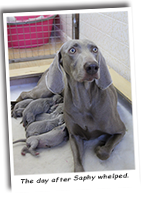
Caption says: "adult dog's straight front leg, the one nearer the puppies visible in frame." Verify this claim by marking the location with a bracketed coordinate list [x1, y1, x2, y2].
[70, 134, 84, 172]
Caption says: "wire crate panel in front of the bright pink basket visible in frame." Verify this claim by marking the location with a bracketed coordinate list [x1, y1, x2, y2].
[7, 14, 75, 63]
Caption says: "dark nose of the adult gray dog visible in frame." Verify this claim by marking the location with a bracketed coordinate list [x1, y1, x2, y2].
[84, 62, 99, 75]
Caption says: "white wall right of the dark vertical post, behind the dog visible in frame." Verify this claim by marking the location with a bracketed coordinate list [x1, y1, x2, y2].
[80, 12, 130, 81]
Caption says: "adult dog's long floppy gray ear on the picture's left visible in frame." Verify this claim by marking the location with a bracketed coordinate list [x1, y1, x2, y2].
[45, 47, 64, 94]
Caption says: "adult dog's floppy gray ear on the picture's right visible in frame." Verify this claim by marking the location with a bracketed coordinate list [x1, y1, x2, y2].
[96, 51, 112, 90]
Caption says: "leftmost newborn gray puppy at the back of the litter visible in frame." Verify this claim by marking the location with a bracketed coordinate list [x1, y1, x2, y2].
[11, 99, 33, 119]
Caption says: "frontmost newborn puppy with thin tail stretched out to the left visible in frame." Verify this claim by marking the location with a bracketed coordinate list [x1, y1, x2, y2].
[13, 123, 68, 156]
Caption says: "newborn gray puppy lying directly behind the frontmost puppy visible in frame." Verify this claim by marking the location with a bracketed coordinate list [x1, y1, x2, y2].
[26, 114, 64, 138]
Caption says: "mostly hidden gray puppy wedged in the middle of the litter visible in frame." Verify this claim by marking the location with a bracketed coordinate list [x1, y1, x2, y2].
[35, 103, 63, 121]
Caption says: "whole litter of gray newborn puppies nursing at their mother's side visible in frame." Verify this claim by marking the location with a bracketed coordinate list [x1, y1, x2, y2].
[11, 95, 68, 156]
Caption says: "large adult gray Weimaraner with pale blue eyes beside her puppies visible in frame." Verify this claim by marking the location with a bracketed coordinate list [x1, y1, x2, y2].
[15, 40, 126, 172]
